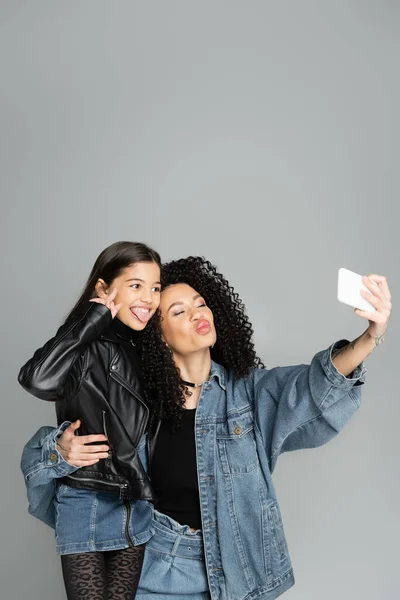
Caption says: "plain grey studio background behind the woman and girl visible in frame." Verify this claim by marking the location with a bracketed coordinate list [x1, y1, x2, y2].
[0, 0, 400, 600]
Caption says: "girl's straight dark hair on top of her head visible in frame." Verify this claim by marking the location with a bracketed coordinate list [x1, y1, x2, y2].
[65, 242, 161, 321]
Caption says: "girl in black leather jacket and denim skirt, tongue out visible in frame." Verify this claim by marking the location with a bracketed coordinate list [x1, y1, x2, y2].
[19, 242, 161, 600]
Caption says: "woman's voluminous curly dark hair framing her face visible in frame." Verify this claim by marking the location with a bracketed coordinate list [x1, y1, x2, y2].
[141, 256, 264, 426]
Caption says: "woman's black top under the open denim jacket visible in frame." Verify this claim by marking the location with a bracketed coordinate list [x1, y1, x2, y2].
[151, 408, 201, 529]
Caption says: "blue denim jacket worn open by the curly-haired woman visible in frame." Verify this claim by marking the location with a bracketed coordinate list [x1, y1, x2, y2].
[22, 340, 366, 600]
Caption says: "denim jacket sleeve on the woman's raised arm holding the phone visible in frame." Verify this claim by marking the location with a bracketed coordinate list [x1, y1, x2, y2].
[254, 340, 366, 471]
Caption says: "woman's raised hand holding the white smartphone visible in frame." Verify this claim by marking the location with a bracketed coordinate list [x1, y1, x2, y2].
[354, 275, 392, 346]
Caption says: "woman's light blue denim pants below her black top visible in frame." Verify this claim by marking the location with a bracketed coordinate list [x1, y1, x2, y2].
[136, 511, 210, 600]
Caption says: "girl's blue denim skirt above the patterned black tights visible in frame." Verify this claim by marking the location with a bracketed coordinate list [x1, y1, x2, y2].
[55, 483, 154, 554]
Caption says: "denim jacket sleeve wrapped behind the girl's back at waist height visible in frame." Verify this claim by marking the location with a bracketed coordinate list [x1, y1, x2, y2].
[21, 421, 79, 529]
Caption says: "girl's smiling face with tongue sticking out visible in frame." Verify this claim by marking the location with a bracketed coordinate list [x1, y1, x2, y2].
[96, 262, 161, 331]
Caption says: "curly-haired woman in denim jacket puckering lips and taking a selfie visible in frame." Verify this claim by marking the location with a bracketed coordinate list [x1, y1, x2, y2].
[21, 257, 391, 600]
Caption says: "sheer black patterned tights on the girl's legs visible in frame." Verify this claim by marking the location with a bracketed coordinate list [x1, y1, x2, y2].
[61, 545, 144, 600]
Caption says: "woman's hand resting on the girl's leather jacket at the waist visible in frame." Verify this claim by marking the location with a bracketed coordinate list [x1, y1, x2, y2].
[56, 419, 110, 467]
